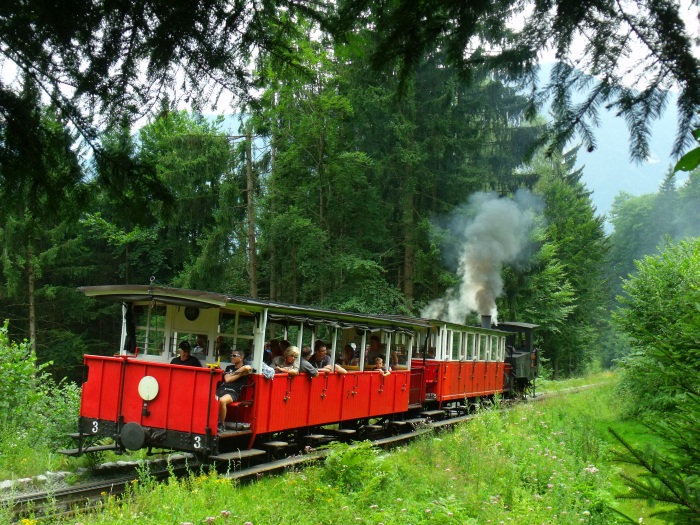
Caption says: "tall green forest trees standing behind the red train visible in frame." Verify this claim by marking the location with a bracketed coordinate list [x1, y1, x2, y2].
[0, 2, 700, 379]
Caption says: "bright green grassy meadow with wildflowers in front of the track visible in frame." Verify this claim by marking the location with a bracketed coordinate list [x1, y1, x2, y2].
[49, 374, 660, 525]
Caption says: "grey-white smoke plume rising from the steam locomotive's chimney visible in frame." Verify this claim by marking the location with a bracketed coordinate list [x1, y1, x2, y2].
[421, 190, 541, 323]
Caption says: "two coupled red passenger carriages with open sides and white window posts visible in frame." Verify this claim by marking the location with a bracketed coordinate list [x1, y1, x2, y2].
[66, 285, 536, 459]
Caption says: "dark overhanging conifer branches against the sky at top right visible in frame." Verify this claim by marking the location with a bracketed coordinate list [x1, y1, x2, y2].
[332, 0, 700, 160]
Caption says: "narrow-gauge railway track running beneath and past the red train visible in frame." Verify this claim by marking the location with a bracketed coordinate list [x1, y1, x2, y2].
[8, 384, 599, 522]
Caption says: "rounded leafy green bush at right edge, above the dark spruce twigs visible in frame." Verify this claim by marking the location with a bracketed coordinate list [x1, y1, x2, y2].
[615, 238, 700, 413]
